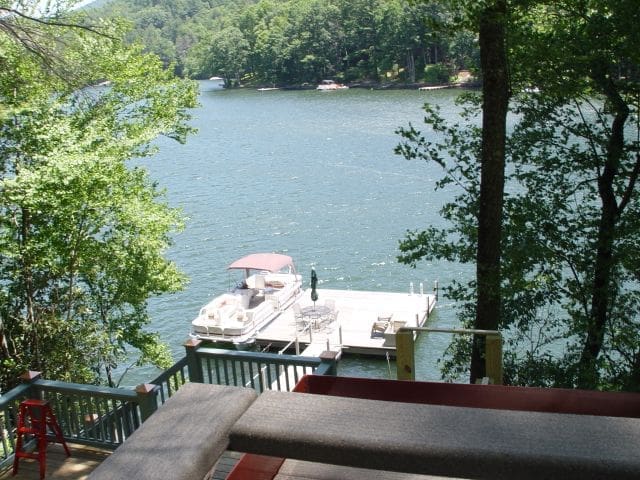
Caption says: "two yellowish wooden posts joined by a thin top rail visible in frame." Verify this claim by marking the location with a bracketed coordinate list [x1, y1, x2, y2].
[396, 326, 503, 385]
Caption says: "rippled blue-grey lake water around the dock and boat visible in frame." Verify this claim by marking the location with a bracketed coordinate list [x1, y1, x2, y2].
[123, 82, 473, 385]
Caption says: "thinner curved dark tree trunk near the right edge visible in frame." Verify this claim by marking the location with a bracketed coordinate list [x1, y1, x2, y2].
[578, 65, 629, 389]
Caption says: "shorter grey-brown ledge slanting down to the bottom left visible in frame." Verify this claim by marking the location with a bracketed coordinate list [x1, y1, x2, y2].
[88, 383, 257, 480]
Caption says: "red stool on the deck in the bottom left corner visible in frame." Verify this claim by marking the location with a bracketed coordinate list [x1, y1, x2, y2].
[13, 399, 71, 480]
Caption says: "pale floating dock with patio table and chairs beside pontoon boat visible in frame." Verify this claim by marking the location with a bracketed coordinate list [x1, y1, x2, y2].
[256, 289, 436, 356]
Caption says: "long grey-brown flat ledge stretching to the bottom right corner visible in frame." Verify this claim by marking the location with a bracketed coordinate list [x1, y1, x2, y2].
[229, 391, 640, 480]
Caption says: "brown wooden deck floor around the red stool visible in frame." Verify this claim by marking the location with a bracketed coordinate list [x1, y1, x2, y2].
[0, 444, 241, 480]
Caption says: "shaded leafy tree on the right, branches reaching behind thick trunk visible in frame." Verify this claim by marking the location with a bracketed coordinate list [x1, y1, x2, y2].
[399, 1, 640, 390]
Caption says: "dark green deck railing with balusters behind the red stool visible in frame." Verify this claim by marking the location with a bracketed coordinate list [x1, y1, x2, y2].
[0, 341, 336, 466]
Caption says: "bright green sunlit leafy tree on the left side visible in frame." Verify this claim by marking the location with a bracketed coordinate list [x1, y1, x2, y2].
[0, 2, 197, 389]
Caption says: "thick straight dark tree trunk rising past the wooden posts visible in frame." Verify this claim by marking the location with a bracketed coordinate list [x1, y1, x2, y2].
[470, 0, 509, 383]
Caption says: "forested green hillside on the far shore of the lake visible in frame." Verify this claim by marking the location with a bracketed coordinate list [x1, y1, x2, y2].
[94, 0, 478, 86]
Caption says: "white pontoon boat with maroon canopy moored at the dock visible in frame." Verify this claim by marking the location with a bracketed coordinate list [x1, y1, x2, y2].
[190, 253, 302, 348]
